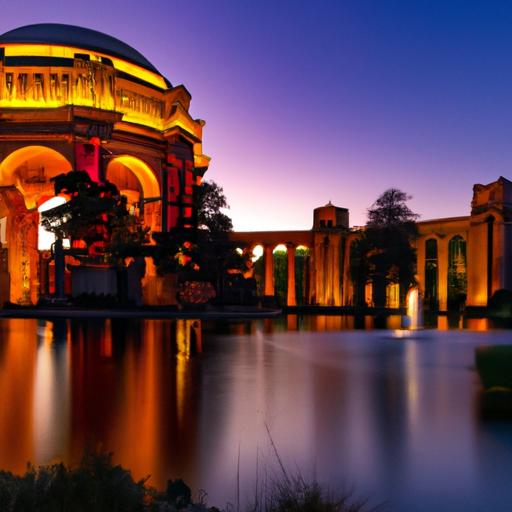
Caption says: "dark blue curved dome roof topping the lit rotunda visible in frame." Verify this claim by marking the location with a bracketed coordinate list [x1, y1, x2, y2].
[0, 23, 160, 75]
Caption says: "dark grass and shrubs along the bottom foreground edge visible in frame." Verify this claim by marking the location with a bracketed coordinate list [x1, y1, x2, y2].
[0, 454, 382, 512]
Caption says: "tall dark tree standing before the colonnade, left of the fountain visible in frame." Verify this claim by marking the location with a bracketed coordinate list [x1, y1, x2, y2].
[351, 188, 418, 307]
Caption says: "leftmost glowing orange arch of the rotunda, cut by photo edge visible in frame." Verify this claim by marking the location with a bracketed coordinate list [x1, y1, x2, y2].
[0, 146, 72, 209]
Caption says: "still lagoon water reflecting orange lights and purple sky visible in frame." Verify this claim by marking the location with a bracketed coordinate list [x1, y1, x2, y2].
[0, 316, 512, 512]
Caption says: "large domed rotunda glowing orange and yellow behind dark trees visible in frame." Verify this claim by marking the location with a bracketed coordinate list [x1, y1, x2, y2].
[0, 24, 209, 304]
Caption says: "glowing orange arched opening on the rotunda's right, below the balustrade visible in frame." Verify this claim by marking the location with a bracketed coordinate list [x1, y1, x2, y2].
[105, 155, 161, 231]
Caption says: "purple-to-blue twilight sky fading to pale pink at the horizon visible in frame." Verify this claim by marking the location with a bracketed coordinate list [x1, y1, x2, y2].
[0, 0, 512, 230]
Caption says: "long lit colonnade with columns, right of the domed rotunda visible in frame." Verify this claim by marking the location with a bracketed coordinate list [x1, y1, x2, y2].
[232, 177, 512, 311]
